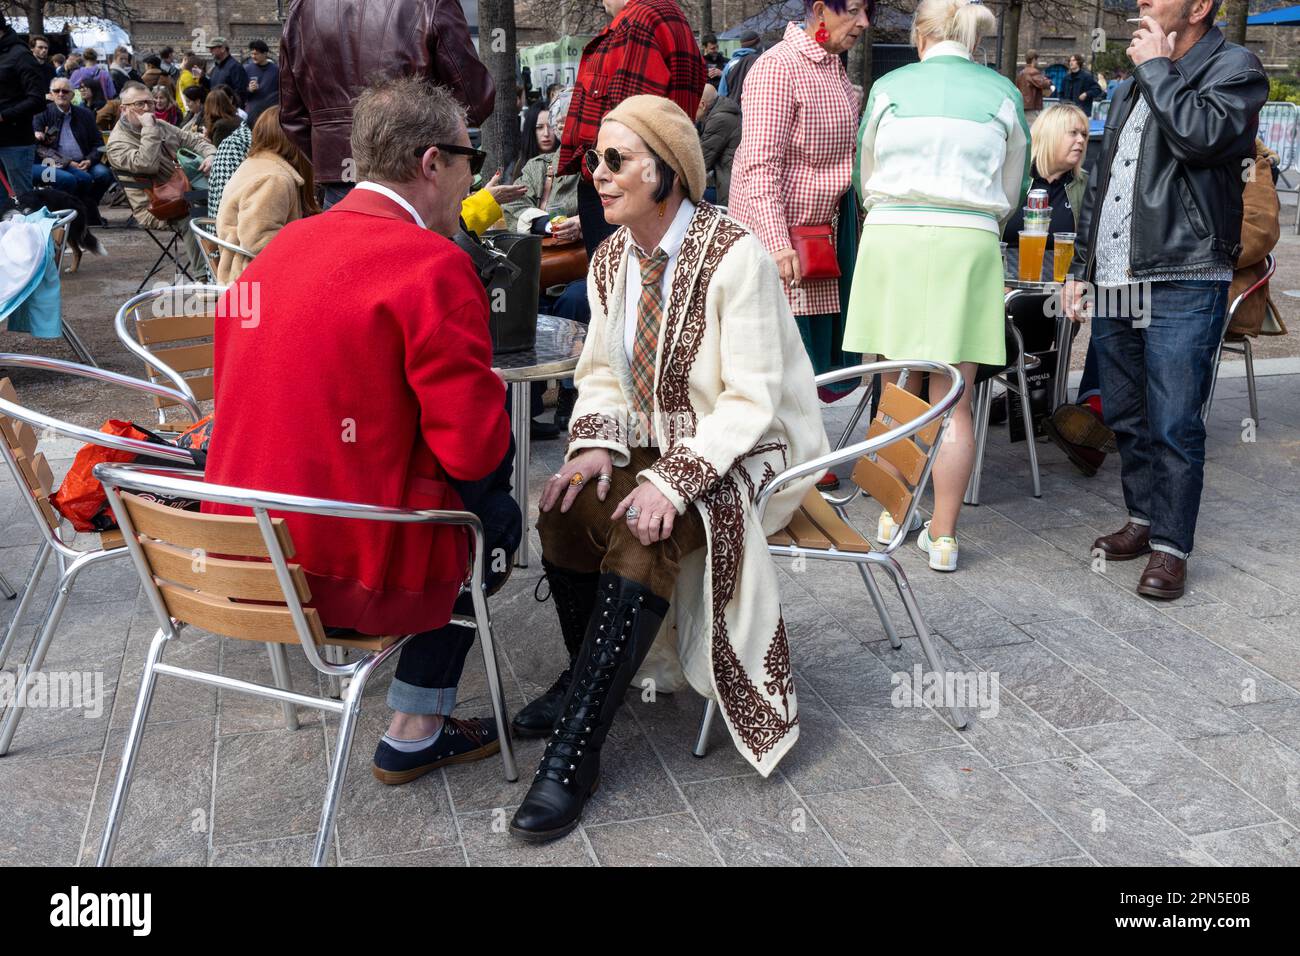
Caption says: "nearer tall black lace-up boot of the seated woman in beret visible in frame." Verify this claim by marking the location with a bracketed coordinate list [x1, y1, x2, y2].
[510, 574, 668, 843]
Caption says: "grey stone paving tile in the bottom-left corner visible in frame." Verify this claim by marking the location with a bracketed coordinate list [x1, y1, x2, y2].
[0, 753, 99, 866]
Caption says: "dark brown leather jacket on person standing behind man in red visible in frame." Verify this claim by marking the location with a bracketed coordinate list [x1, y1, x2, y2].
[280, 0, 497, 182]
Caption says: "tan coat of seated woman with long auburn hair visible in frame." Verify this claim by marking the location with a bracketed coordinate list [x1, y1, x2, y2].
[217, 152, 303, 285]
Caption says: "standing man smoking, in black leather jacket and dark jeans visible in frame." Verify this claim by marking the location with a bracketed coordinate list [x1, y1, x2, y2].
[1063, 0, 1269, 600]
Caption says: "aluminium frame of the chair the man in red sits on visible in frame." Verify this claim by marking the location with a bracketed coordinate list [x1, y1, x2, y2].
[95, 463, 519, 866]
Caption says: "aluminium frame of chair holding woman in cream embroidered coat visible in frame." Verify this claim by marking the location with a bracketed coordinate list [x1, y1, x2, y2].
[693, 359, 970, 757]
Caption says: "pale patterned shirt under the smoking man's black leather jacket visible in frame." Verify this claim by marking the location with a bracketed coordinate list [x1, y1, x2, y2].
[1093, 90, 1232, 286]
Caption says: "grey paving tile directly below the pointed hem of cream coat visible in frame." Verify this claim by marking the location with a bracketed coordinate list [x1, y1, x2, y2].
[683, 777, 844, 866]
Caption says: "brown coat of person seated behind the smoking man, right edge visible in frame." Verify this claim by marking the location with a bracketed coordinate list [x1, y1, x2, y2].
[1227, 139, 1287, 336]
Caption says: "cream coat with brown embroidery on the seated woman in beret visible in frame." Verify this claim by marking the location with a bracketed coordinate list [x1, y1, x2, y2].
[568, 203, 829, 777]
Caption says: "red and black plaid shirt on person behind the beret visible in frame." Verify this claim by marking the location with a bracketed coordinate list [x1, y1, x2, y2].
[559, 0, 707, 179]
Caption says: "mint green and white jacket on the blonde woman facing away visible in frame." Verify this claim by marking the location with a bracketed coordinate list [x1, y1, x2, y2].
[853, 42, 1030, 235]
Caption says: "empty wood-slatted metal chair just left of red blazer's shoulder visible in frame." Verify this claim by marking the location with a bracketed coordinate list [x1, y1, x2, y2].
[113, 285, 225, 432]
